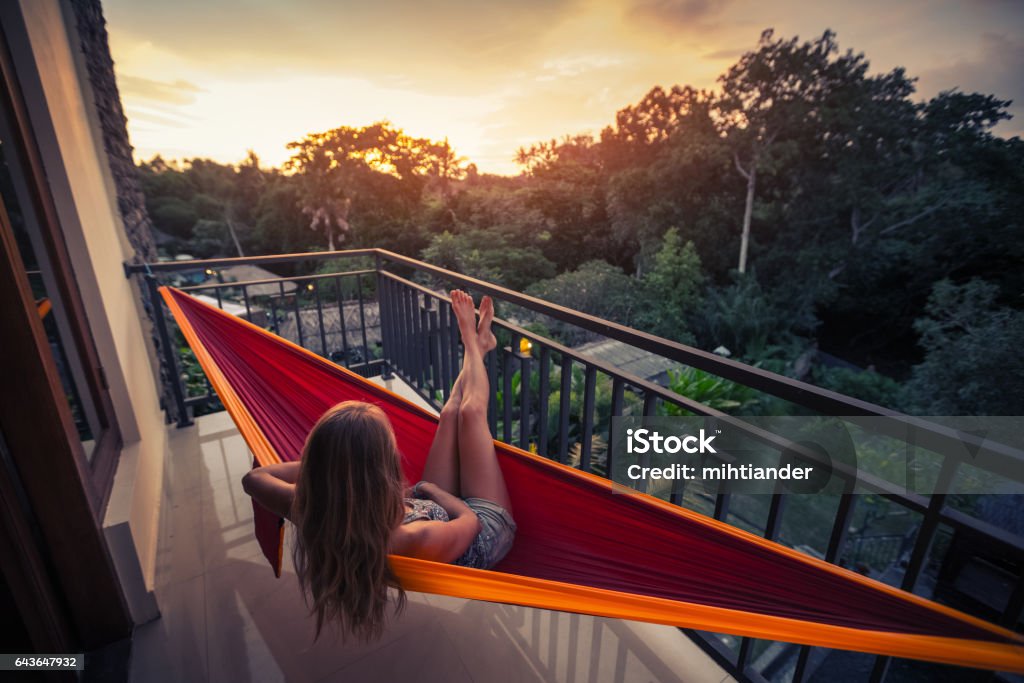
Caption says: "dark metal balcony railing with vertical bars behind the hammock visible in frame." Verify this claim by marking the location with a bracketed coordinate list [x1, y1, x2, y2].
[125, 249, 1024, 683]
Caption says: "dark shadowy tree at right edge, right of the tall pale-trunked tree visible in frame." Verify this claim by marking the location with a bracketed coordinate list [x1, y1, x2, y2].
[802, 90, 1024, 376]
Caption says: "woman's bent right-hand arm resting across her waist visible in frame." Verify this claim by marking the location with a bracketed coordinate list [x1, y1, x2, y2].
[391, 481, 480, 562]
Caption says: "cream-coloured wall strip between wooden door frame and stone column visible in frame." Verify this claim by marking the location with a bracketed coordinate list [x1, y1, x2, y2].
[11, 0, 168, 623]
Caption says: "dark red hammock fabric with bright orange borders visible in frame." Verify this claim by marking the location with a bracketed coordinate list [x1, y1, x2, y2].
[161, 288, 1024, 673]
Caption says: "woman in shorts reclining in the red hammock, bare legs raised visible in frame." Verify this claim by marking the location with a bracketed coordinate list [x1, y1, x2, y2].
[242, 291, 516, 638]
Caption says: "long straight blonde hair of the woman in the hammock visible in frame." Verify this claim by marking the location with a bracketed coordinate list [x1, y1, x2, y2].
[292, 400, 406, 640]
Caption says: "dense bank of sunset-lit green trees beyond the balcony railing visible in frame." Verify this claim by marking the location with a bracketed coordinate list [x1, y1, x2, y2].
[141, 32, 1024, 414]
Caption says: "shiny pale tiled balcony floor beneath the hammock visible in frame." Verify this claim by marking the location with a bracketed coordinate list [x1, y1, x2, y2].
[131, 413, 731, 683]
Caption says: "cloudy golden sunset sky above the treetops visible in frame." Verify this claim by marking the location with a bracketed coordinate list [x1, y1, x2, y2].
[103, 0, 1024, 173]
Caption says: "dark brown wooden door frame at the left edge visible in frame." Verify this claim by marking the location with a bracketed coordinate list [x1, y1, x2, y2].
[0, 13, 132, 651]
